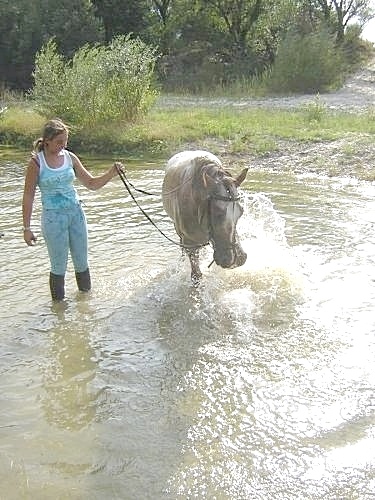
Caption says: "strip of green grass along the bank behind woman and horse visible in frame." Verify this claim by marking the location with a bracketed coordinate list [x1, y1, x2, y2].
[0, 99, 375, 155]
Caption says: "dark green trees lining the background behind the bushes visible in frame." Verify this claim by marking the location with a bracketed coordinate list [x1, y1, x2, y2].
[0, 0, 374, 92]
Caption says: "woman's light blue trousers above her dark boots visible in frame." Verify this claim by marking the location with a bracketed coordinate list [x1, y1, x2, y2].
[41, 204, 88, 275]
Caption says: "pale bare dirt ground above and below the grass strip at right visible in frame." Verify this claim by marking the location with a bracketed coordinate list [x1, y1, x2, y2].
[167, 59, 375, 181]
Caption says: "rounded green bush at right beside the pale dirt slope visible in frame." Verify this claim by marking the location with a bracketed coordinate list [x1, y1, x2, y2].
[270, 30, 343, 93]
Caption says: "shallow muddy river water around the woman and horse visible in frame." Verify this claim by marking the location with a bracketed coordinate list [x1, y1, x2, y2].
[0, 152, 375, 500]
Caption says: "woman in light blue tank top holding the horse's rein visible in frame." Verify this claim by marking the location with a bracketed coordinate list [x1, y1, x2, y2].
[22, 119, 123, 301]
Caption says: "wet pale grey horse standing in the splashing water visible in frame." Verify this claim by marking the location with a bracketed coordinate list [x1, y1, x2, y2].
[162, 151, 247, 281]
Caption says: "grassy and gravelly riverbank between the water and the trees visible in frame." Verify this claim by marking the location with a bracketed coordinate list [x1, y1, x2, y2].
[0, 61, 375, 181]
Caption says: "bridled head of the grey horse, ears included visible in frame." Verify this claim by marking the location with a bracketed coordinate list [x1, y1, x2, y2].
[202, 165, 248, 268]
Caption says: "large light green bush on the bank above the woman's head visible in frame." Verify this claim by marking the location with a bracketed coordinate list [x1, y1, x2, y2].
[31, 37, 156, 128]
